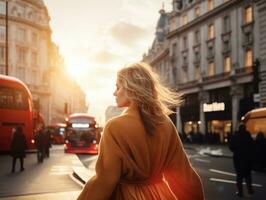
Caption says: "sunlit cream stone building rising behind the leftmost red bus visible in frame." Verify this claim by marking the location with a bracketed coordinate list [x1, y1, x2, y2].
[0, 0, 86, 124]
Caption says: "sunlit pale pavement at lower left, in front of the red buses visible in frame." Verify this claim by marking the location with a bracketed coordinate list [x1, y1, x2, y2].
[0, 145, 82, 200]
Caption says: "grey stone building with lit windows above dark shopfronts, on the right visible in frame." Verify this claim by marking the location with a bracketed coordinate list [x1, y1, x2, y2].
[144, 0, 260, 142]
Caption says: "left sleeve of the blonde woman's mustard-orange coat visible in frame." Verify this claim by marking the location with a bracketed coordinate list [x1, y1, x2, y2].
[78, 121, 121, 200]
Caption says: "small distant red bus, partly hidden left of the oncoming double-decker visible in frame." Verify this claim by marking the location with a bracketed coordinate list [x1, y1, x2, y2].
[45, 123, 66, 144]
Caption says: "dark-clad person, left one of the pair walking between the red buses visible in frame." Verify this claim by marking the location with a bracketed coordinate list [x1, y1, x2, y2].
[34, 126, 45, 163]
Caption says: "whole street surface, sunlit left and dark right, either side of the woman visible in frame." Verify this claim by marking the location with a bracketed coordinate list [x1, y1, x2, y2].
[0, 144, 266, 200]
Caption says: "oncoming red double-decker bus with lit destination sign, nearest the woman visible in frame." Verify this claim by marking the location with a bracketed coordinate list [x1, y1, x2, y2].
[65, 113, 101, 154]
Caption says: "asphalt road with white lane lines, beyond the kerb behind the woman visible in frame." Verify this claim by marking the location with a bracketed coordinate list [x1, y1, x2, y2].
[78, 146, 266, 200]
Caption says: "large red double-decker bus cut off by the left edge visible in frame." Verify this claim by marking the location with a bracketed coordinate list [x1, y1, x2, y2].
[0, 75, 34, 151]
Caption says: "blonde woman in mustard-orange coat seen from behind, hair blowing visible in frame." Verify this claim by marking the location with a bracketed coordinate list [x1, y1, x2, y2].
[78, 62, 204, 200]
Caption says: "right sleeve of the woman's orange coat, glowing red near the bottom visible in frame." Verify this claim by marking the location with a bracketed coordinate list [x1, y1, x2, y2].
[164, 126, 204, 200]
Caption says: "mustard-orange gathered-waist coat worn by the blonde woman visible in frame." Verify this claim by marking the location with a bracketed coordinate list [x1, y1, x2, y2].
[78, 107, 204, 200]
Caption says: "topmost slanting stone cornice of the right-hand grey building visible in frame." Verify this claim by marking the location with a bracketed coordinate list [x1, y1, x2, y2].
[166, 0, 244, 39]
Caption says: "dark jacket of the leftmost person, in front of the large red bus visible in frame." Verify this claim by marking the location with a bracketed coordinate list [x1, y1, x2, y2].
[10, 131, 27, 158]
